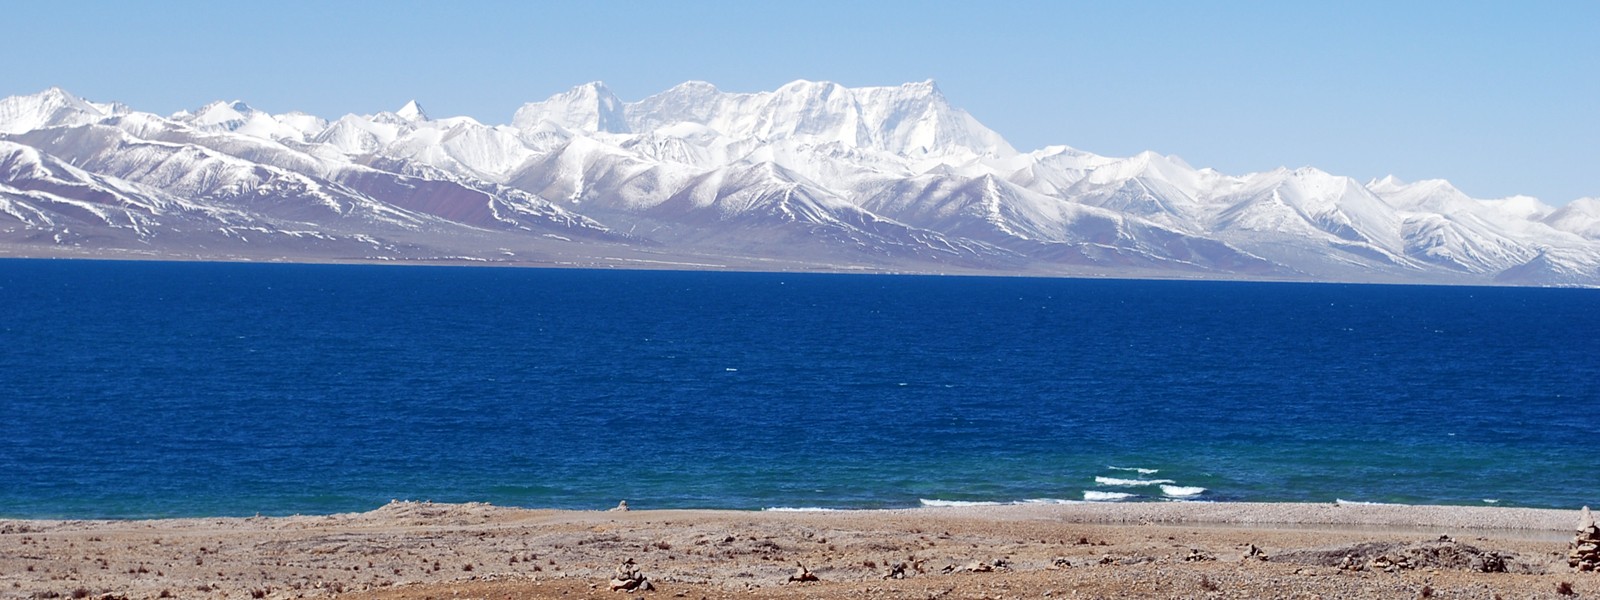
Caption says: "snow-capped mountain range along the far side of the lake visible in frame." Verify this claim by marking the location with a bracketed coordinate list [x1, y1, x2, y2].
[0, 82, 1600, 286]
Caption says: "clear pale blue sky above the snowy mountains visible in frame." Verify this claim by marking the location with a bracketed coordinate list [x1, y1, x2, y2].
[0, 0, 1600, 205]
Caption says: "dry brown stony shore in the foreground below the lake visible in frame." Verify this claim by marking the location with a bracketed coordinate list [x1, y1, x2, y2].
[0, 502, 1600, 600]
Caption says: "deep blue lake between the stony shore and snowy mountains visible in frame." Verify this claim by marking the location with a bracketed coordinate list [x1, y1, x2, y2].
[0, 261, 1600, 517]
